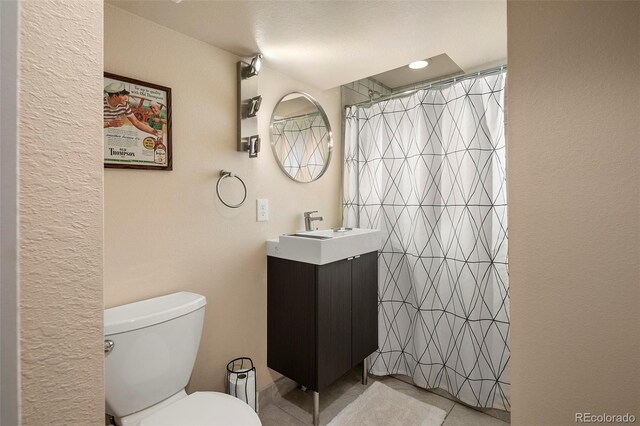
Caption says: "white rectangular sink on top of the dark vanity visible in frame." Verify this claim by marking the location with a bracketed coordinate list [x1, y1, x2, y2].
[267, 228, 382, 265]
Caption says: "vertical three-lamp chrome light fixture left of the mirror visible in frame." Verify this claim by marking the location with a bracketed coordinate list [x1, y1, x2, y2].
[237, 53, 262, 158]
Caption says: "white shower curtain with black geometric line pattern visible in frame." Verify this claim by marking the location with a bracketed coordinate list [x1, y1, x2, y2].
[343, 71, 510, 411]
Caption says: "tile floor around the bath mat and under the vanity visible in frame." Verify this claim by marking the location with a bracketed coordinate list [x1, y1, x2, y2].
[260, 369, 509, 426]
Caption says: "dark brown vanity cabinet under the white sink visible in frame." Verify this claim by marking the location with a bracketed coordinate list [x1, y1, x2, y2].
[267, 252, 378, 392]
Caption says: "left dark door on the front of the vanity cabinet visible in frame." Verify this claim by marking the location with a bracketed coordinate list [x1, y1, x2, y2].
[317, 260, 352, 390]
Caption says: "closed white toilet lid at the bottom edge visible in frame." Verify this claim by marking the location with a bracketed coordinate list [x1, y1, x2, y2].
[140, 392, 262, 426]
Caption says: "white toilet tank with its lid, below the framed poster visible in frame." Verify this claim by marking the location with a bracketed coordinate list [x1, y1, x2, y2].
[104, 292, 207, 417]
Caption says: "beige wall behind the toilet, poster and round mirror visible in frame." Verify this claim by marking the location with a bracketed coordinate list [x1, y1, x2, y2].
[104, 6, 341, 391]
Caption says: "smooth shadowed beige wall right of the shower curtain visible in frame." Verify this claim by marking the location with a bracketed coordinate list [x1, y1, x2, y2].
[507, 1, 640, 425]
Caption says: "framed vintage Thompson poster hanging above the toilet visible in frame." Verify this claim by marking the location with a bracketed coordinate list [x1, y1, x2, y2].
[103, 72, 172, 170]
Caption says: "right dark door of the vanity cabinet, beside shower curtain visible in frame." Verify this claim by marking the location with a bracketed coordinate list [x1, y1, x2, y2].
[350, 252, 378, 366]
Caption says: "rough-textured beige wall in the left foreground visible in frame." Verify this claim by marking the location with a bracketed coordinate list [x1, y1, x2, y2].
[19, 1, 104, 426]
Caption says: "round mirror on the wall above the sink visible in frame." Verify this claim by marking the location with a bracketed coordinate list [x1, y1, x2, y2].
[271, 92, 333, 182]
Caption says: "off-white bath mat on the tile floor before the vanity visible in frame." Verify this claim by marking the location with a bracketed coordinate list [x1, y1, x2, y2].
[327, 382, 447, 426]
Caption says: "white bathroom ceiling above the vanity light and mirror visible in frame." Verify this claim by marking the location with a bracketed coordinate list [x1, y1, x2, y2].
[107, 0, 507, 89]
